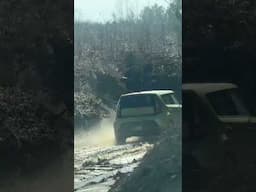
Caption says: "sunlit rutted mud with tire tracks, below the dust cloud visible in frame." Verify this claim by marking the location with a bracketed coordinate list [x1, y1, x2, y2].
[74, 143, 153, 192]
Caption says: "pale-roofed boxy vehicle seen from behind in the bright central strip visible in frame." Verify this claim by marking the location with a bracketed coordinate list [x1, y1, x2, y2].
[114, 90, 181, 144]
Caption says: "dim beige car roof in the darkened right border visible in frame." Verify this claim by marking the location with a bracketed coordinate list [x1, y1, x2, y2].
[182, 83, 237, 94]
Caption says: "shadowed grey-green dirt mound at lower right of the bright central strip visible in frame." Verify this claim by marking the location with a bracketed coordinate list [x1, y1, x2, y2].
[111, 127, 181, 192]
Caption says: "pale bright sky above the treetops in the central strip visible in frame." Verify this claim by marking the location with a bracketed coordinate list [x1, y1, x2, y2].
[74, 0, 167, 22]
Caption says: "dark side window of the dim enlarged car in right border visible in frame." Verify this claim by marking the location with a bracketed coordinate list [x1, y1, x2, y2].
[207, 89, 249, 116]
